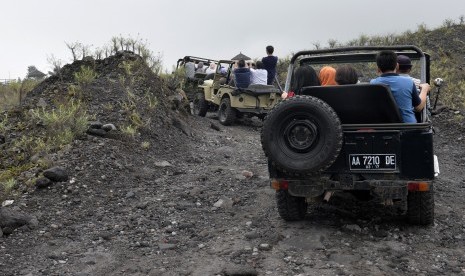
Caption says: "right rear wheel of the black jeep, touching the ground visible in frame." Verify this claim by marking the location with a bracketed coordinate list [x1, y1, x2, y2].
[407, 186, 434, 225]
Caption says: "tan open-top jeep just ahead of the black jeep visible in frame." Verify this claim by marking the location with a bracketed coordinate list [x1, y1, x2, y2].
[193, 60, 281, 125]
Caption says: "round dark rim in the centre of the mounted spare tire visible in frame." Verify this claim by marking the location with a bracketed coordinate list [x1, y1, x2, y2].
[284, 119, 319, 152]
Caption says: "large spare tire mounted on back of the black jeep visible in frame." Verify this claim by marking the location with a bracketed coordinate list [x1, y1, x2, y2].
[261, 96, 342, 175]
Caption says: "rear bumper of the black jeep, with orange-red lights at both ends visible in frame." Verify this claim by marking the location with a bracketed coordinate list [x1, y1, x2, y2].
[271, 179, 433, 199]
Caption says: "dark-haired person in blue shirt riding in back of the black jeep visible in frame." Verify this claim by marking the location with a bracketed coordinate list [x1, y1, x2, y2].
[370, 50, 431, 123]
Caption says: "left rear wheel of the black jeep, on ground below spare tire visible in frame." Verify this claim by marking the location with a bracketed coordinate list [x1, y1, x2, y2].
[276, 190, 307, 221]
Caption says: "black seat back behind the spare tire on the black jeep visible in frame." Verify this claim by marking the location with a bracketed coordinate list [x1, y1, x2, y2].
[299, 84, 402, 124]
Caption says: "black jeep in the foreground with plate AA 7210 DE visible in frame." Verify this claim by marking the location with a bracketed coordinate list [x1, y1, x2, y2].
[261, 46, 439, 225]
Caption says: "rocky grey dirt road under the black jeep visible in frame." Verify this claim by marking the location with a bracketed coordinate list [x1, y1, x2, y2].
[0, 109, 465, 275]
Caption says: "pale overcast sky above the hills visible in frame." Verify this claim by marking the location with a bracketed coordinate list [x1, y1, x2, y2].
[0, 0, 465, 79]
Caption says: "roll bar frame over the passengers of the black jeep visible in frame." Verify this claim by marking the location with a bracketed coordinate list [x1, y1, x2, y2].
[284, 45, 429, 91]
